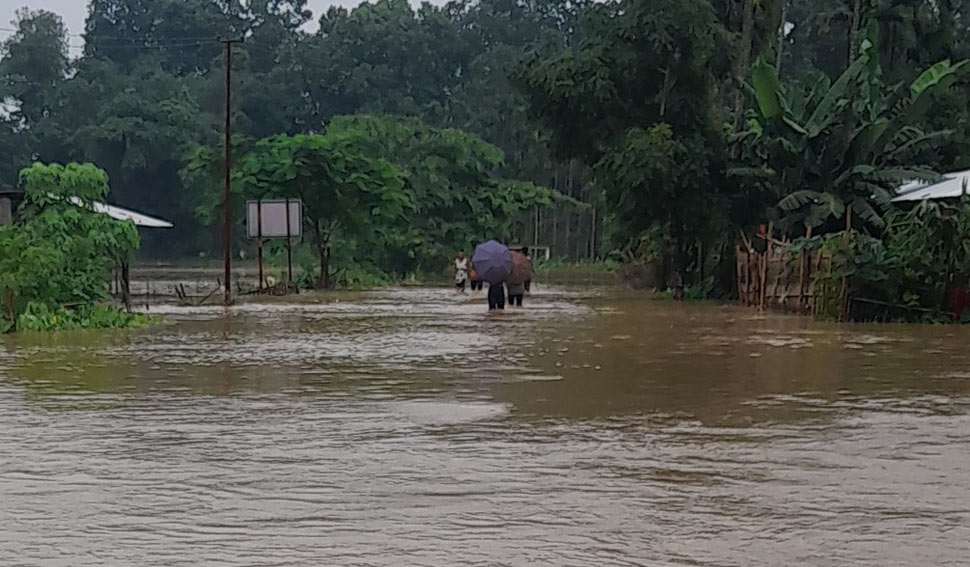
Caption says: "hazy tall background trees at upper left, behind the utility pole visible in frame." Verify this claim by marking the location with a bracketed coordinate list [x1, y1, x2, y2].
[0, 0, 587, 262]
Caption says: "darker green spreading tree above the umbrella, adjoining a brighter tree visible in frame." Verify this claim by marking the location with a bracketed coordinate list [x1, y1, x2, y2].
[327, 115, 579, 275]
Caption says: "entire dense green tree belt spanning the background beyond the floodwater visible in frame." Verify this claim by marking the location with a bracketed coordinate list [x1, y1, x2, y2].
[0, 0, 970, 316]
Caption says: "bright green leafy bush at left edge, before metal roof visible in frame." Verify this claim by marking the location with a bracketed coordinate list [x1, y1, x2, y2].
[0, 163, 138, 327]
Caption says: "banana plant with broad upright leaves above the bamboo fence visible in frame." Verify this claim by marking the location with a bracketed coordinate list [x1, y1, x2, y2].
[733, 39, 966, 237]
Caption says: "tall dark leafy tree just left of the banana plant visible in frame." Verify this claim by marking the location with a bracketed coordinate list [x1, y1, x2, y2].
[518, 0, 727, 284]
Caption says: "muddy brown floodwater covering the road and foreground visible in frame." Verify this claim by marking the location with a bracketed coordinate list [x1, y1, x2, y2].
[0, 288, 970, 567]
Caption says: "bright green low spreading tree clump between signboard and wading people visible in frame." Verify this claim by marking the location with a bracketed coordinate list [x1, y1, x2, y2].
[184, 115, 564, 286]
